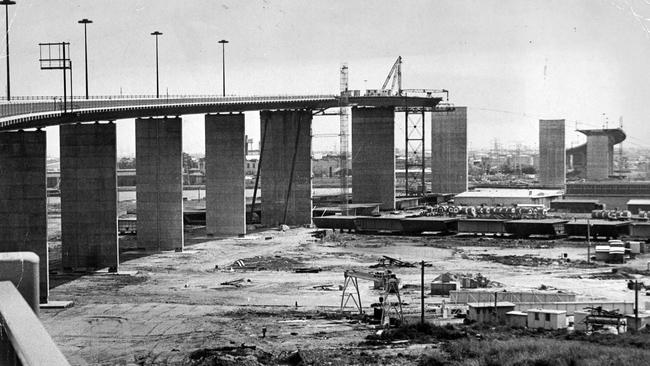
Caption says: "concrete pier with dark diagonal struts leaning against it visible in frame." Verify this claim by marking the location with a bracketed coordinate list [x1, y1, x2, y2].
[256, 110, 312, 226]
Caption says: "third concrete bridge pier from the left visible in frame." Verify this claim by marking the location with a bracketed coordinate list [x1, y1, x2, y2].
[135, 117, 184, 251]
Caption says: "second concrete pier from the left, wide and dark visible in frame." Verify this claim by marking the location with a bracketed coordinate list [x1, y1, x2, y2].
[59, 122, 119, 272]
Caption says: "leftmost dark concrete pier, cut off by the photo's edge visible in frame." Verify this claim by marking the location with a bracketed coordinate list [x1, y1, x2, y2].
[0, 130, 49, 303]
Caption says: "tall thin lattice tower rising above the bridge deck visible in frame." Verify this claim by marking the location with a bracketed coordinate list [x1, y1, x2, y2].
[339, 64, 349, 215]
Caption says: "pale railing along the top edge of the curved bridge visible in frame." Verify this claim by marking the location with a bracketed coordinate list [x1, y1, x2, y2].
[0, 94, 335, 117]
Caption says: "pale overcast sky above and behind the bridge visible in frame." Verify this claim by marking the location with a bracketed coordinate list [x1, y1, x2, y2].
[8, 0, 650, 153]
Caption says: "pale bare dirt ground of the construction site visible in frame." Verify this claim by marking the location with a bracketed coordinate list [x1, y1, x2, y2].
[41, 222, 650, 365]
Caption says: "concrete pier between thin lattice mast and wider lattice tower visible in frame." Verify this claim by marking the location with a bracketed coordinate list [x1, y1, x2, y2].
[352, 107, 395, 210]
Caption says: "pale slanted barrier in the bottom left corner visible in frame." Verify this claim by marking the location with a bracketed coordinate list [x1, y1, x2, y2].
[0, 281, 70, 366]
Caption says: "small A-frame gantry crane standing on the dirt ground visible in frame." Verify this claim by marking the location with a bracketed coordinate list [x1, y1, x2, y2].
[341, 270, 404, 325]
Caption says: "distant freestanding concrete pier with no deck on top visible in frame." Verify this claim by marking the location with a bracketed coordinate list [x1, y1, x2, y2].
[539, 119, 566, 188]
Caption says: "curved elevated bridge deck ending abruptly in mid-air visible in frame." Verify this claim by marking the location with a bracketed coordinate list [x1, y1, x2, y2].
[0, 95, 442, 131]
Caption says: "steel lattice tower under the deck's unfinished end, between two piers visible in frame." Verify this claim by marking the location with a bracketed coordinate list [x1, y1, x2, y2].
[404, 108, 427, 197]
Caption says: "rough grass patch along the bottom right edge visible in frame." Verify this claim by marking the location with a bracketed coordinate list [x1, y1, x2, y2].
[412, 324, 650, 366]
